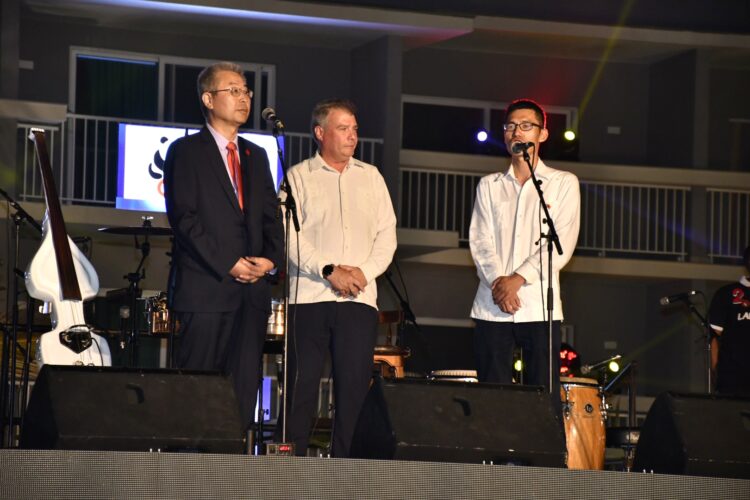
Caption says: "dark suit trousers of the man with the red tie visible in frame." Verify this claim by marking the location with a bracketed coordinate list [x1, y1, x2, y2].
[176, 303, 268, 428]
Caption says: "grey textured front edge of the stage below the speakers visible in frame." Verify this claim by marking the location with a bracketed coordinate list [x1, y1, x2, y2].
[0, 449, 750, 500]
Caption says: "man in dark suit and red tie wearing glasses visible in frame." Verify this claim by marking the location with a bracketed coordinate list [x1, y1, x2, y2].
[164, 63, 283, 426]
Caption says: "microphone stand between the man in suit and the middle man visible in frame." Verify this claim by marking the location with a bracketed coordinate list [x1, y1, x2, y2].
[270, 122, 300, 454]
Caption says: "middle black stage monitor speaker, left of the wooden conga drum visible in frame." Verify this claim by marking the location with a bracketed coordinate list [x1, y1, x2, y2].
[351, 377, 565, 467]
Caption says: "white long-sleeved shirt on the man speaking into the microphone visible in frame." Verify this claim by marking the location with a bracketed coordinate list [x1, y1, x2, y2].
[469, 159, 581, 323]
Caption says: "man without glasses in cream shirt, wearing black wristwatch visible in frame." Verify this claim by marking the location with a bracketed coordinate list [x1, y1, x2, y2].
[277, 100, 396, 457]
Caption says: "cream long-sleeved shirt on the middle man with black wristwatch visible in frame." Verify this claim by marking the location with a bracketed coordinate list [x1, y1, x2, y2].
[288, 153, 396, 308]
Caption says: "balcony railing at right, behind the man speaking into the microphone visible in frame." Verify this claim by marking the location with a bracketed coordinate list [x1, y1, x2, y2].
[399, 168, 732, 261]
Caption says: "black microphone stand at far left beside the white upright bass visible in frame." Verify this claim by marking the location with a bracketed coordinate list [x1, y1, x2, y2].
[0, 189, 42, 447]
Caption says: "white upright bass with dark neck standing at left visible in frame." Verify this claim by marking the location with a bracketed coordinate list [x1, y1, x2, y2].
[26, 129, 112, 366]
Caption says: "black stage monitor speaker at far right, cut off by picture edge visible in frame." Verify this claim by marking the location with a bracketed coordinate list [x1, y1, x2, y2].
[633, 392, 750, 478]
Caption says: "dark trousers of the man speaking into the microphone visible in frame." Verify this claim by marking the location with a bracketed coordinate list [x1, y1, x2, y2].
[474, 319, 562, 419]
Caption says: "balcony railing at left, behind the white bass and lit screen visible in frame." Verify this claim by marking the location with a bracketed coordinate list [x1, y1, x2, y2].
[16, 114, 383, 206]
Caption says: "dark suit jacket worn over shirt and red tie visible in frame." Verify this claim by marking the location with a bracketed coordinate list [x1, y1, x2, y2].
[164, 127, 284, 312]
